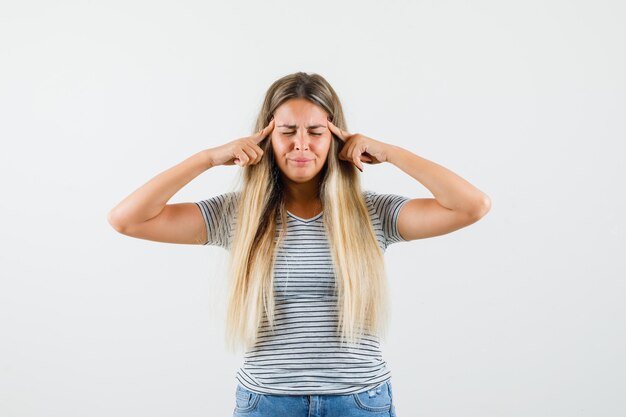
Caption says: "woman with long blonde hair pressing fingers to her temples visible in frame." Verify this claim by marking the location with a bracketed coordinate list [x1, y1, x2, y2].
[109, 72, 490, 416]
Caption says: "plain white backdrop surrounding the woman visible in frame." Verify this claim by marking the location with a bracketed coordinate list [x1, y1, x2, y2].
[0, 0, 626, 417]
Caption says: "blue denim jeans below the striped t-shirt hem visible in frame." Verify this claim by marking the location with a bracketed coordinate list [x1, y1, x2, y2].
[233, 381, 396, 417]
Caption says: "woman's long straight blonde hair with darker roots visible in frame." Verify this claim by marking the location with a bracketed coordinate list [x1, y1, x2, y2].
[225, 72, 389, 350]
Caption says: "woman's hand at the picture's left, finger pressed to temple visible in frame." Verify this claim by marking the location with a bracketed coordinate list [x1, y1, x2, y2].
[211, 117, 274, 167]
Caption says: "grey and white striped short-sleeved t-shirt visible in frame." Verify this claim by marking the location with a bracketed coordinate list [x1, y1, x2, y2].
[196, 191, 409, 395]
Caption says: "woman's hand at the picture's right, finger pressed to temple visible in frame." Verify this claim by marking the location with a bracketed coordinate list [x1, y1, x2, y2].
[327, 120, 389, 172]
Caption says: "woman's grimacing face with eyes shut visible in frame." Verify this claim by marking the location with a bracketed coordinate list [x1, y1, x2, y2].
[271, 98, 332, 183]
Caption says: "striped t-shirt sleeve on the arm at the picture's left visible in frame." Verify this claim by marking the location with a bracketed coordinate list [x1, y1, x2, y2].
[195, 192, 236, 249]
